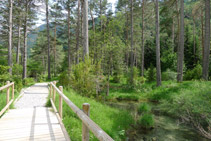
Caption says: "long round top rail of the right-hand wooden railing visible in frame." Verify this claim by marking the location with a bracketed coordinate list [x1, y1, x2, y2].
[51, 82, 113, 141]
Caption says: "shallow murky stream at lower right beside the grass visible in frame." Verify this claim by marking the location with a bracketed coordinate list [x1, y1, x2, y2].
[106, 102, 208, 141]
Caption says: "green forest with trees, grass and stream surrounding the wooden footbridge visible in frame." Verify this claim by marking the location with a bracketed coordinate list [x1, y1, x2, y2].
[0, 0, 211, 141]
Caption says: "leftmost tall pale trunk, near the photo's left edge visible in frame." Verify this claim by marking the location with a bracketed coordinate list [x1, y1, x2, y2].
[8, 0, 13, 75]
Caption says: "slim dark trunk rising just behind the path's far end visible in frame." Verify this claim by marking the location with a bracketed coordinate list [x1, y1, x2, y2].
[46, 0, 51, 79]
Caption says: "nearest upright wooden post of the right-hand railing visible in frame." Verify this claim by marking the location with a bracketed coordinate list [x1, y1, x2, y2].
[82, 103, 90, 141]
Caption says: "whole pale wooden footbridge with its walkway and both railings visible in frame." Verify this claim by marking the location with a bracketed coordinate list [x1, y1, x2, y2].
[0, 81, 113, 141]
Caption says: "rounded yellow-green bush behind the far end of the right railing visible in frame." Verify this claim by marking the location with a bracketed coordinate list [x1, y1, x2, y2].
[59, 59, 106, 97]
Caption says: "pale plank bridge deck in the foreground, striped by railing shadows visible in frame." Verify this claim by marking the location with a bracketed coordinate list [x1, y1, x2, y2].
[0, 83, 65, 141]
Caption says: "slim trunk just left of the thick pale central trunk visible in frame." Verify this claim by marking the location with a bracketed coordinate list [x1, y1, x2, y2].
[76, 0, 81, 64]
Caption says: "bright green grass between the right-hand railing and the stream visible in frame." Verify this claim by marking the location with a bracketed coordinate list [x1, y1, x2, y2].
[50, 90, 134, 141]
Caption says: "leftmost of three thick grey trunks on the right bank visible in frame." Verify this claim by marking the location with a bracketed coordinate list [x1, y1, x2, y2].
[155, 0, 161, 86]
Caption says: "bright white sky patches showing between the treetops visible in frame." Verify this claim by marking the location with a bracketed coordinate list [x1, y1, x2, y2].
[36, 0, 118, 26]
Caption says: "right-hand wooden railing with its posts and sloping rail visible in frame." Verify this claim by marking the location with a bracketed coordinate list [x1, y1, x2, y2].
[50, 81, 113, 141]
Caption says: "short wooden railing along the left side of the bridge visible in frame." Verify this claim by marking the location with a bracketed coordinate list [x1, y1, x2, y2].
[0, 81, 14, 116]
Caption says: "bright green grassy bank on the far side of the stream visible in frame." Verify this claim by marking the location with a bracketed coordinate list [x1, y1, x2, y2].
[108, 81, 211, 101]
